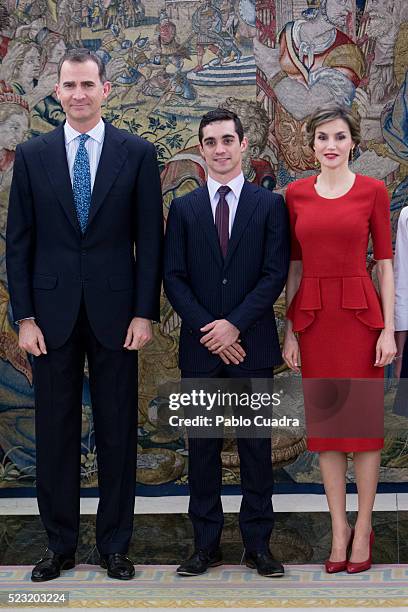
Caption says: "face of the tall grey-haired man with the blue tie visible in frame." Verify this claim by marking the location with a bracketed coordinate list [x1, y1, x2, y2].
[55, 60, 111, 127]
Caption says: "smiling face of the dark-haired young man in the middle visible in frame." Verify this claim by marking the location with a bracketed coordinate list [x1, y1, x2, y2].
[200, 119, 248, 182]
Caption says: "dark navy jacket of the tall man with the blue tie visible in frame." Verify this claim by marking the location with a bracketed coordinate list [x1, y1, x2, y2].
[7, 123, 163, 350]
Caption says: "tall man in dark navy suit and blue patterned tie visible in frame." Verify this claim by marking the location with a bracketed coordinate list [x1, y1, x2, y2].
[7, 49, 162, 582]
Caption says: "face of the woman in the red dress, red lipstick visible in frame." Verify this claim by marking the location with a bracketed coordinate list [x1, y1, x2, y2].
[314, 119, 354, 169]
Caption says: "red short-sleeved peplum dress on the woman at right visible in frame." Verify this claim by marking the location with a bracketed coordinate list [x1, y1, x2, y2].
[286, 174, 392, 452]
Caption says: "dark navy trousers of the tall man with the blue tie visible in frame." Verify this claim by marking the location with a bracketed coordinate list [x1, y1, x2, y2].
[34, 301, 137, 554]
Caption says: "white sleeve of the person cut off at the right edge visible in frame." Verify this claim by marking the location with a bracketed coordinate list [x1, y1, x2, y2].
[394, 206, 408, 331]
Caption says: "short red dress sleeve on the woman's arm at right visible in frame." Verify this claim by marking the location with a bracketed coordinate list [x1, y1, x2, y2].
[370, 182, 392, 260]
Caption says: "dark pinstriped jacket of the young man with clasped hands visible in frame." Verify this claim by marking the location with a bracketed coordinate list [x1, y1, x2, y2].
[164, 181, 289, 372]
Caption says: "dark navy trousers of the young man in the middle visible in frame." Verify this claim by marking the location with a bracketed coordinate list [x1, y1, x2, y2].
[181, 364, 274, 552]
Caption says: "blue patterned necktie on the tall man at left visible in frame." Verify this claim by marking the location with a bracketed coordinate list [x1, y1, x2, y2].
[72, 134, 91, 233]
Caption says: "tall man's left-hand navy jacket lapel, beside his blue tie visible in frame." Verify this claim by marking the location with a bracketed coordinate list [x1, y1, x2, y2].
[40, 125, 81, 232]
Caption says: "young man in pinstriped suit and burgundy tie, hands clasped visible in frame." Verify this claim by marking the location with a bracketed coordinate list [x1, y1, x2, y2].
[164, 109, 289, 576]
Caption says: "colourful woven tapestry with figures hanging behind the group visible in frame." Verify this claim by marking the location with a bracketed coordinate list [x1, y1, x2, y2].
[0, 0, 408, 492]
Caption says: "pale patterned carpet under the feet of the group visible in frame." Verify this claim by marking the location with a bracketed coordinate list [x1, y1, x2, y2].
[0, 565, 408, 609]
